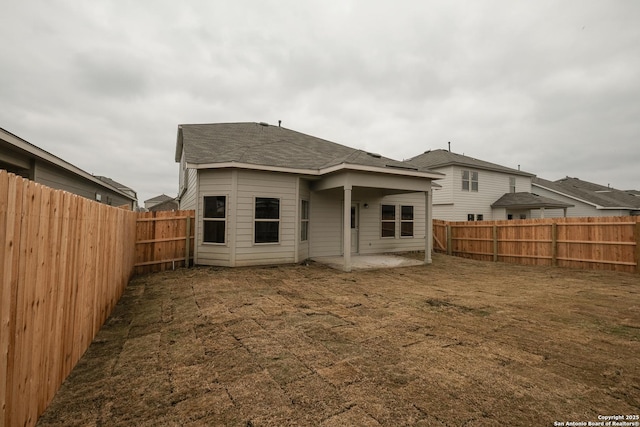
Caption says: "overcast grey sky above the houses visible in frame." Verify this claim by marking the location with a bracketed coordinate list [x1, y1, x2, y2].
[0, 0, 640, 204]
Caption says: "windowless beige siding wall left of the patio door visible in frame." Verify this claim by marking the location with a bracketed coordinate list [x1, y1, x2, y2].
[309, 189, 344, 257]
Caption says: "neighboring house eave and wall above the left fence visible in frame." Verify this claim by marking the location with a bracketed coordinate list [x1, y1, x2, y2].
[0, 128, 137, 210]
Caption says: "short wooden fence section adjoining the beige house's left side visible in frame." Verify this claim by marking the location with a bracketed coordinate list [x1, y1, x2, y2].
[135, 210, 195, 274]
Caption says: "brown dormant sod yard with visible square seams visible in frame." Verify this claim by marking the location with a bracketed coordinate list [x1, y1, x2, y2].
[38, 254, 640, 426]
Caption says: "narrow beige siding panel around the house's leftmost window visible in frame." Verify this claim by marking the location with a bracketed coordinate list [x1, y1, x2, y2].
[198, 170, 233, 266]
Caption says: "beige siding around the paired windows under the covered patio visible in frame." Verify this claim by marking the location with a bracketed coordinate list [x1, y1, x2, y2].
[359, 193, 425, 254]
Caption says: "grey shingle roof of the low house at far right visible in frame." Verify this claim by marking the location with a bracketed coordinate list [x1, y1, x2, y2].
[532, 177, 640, 210]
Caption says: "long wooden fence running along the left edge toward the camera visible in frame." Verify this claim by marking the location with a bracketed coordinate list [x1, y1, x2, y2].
[0, 170, 136, 426]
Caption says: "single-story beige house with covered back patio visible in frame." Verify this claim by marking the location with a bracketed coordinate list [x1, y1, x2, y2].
[175, 123, 442, 271]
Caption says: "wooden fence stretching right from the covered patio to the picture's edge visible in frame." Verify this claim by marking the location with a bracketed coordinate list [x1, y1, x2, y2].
[433, 216, 640, 273]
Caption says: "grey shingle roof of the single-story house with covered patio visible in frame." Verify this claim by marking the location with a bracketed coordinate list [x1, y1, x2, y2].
[175, 123, 441, 177]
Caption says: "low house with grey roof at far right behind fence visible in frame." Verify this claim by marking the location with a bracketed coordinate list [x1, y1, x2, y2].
[532, 177, 640, 217]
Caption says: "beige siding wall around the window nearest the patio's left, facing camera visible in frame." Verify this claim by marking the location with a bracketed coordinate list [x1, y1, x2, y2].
[235, 171, 298, 266]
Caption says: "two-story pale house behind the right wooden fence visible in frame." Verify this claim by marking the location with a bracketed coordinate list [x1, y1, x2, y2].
[408, 150, 571, 221]
